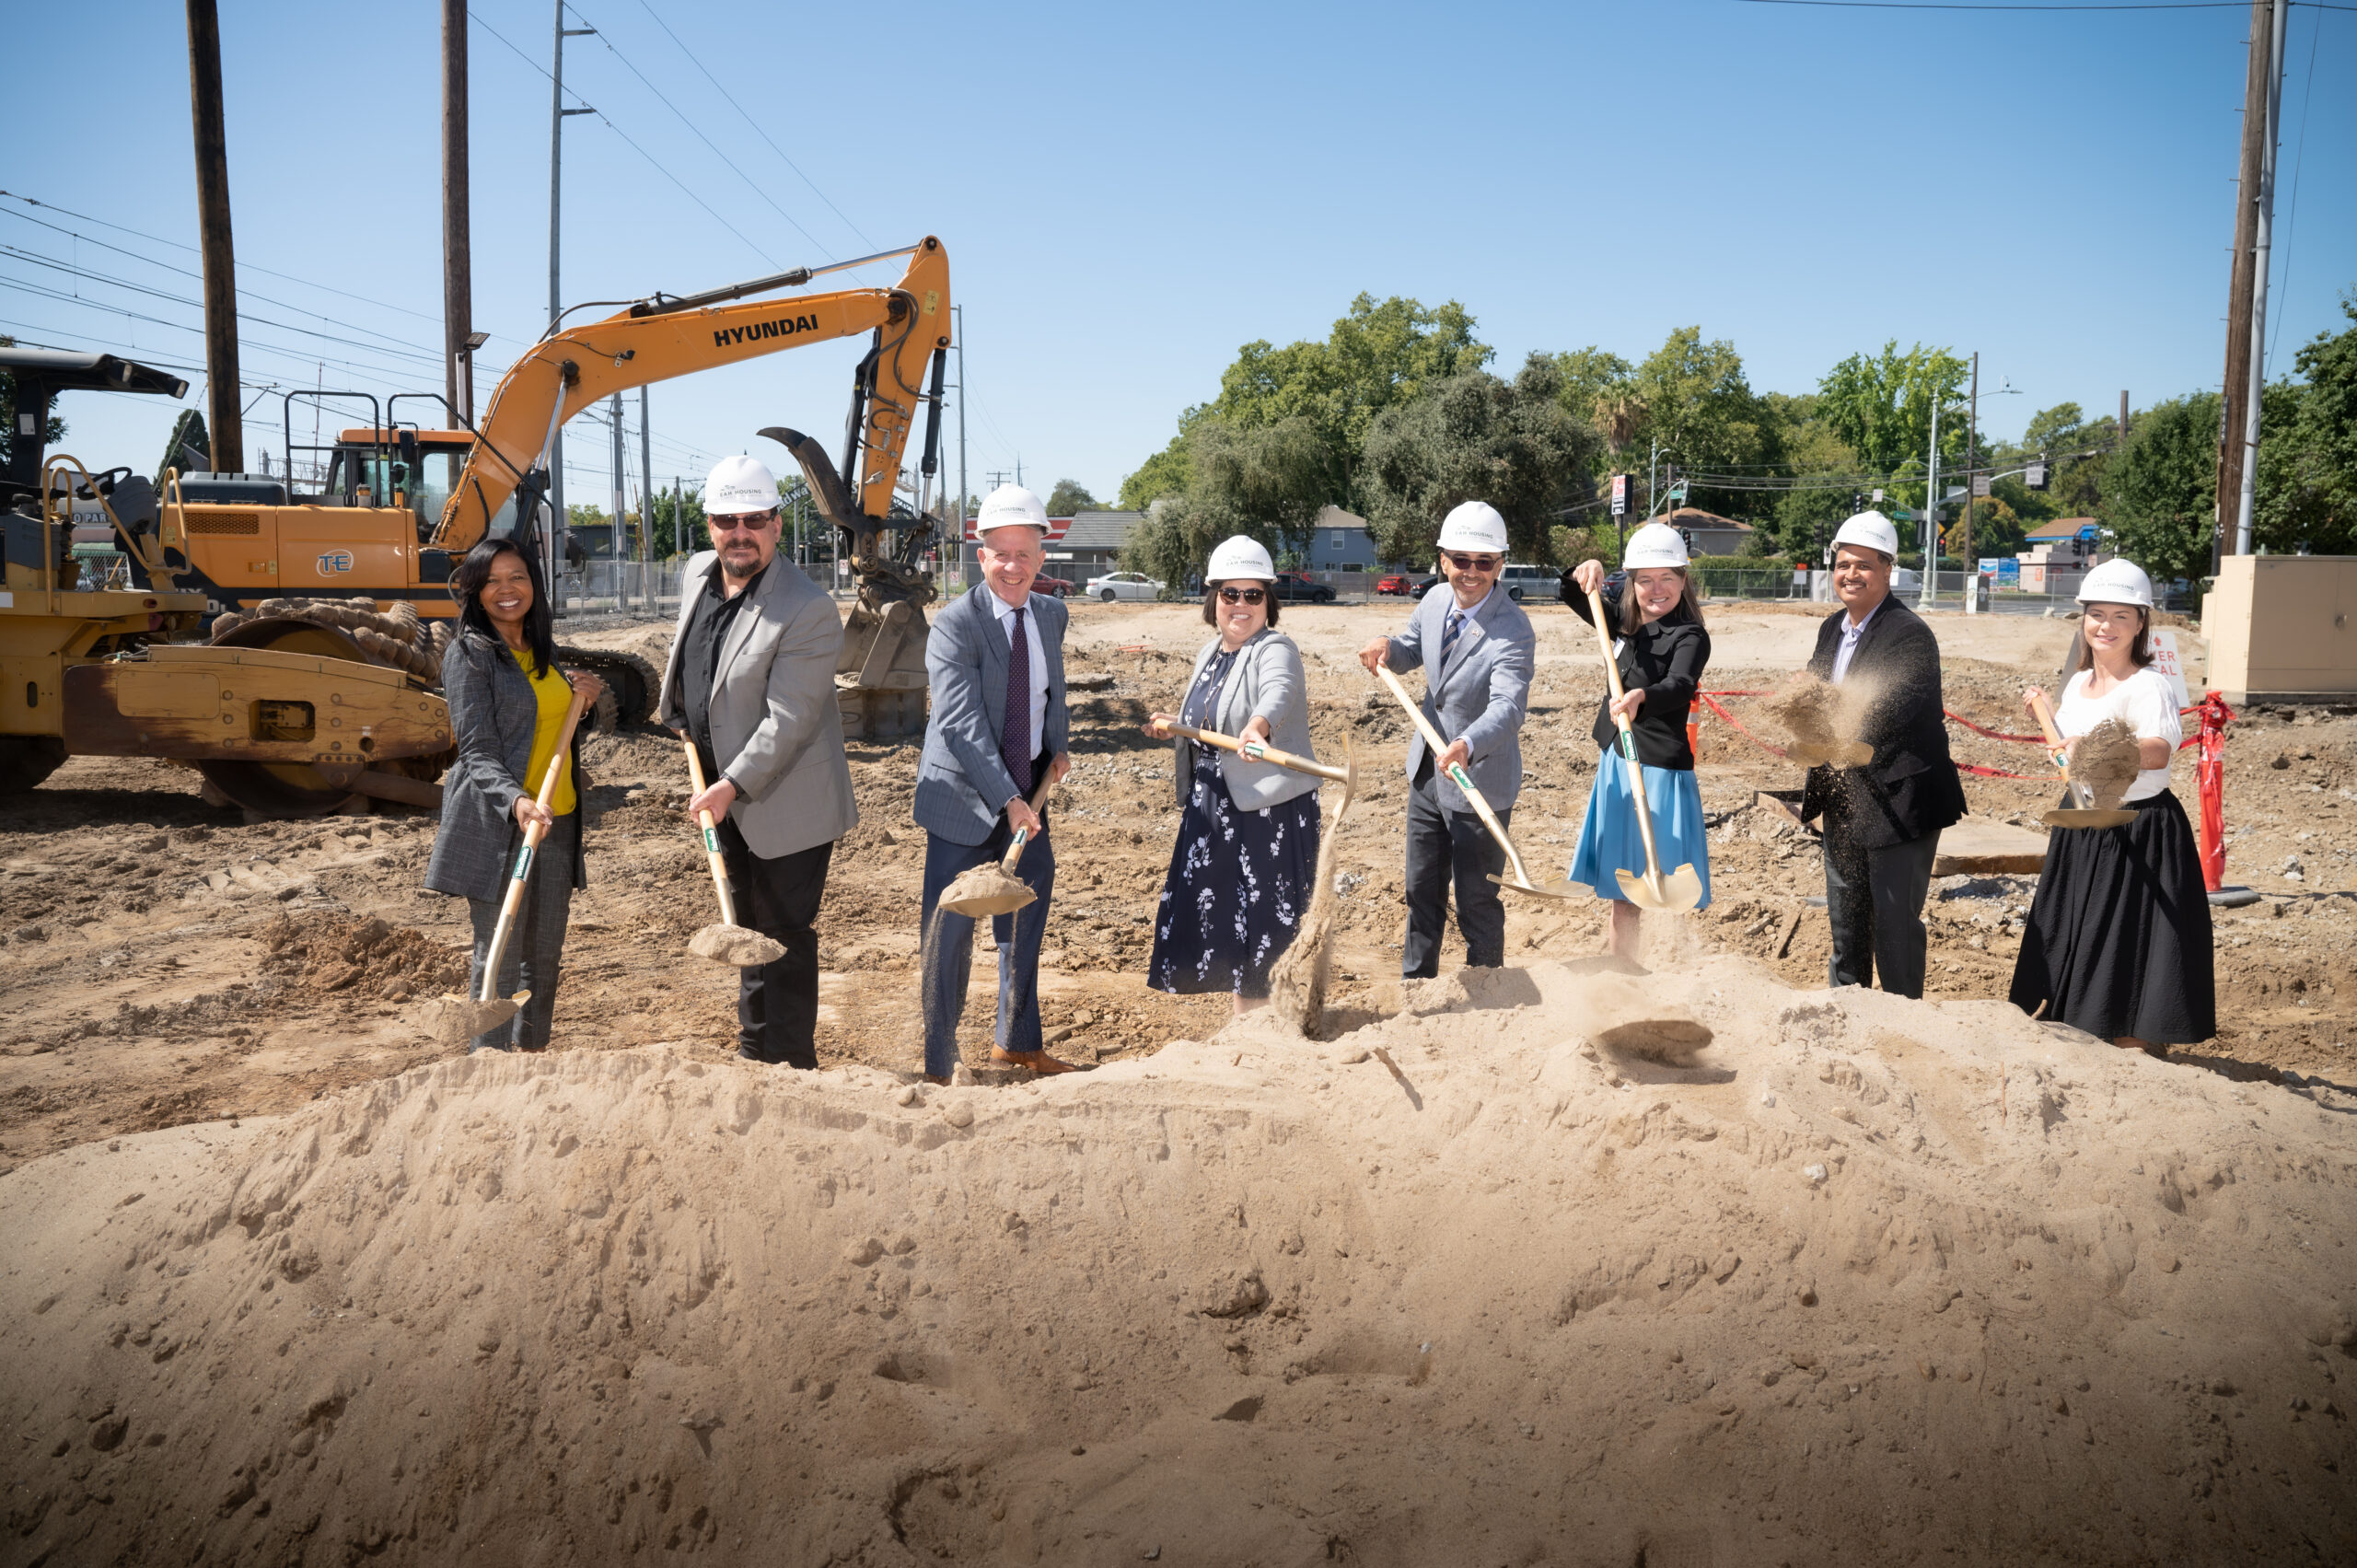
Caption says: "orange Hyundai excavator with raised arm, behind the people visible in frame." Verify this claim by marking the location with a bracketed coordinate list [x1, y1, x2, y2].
[122, 236, 955, 783]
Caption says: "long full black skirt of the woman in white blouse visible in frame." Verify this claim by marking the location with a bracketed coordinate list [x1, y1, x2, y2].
[2011, 790, 2218, 1044]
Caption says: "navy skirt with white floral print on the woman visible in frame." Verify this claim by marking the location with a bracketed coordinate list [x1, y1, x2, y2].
[1145, 760, 1318, 1000]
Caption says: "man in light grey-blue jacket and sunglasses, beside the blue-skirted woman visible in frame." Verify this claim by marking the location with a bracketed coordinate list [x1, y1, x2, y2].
[1358, 500, 1537, 981]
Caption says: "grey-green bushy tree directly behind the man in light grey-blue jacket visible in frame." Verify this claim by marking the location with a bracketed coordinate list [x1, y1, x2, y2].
[1363, 354, 1598, 561]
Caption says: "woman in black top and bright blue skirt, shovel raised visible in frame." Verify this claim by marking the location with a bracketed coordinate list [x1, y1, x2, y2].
[1562, 524, 1712, 962]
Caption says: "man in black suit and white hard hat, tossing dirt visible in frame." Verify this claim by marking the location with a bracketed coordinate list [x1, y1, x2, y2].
[1801, 512, 1963, 997]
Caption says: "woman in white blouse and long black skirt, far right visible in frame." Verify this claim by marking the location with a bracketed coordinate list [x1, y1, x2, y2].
[2011, 561, 2218, 1056]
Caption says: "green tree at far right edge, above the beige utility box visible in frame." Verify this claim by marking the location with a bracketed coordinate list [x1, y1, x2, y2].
[2251, 290, 2357, 554]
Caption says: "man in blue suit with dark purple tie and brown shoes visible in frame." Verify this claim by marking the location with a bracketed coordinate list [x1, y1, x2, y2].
[914, 486, 1073, 1082]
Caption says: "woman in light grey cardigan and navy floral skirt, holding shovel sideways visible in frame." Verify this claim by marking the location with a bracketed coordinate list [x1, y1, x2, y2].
[1145, 538, 1318, 1014]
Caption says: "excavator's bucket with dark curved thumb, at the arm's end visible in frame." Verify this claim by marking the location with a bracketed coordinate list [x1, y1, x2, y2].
[761, 424, 934, 740]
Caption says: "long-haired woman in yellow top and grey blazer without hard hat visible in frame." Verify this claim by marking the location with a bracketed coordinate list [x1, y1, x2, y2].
[426, 538, 603, 1051]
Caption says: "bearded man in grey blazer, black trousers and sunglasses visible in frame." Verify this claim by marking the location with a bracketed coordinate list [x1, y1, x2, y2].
[656, 458, 860, 1068]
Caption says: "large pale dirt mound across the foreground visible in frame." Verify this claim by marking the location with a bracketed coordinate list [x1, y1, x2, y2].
[0, 959, 2357, 1563]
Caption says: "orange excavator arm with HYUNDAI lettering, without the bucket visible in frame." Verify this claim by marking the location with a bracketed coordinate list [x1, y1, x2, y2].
[429, 236, 950, 559]
